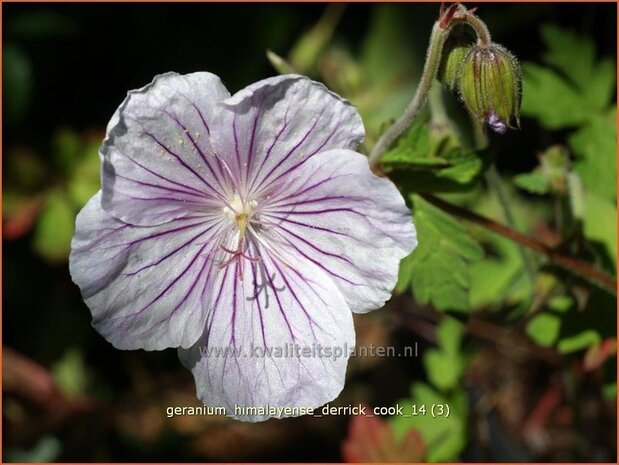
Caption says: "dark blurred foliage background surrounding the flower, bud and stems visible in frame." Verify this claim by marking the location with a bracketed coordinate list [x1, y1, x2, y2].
[2, 3, 617, 462]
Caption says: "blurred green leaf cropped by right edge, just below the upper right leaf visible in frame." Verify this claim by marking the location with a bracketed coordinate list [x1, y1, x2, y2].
[568, 109, 617, 202]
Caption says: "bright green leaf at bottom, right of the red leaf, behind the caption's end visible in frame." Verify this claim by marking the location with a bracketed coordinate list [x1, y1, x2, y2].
[390, 383, 467, 462]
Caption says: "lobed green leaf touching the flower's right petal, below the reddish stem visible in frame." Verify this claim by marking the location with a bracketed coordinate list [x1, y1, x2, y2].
[400, 195, 483, 312]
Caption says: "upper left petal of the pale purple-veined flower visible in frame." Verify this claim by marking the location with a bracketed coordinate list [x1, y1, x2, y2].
[100, 73, 230, 226]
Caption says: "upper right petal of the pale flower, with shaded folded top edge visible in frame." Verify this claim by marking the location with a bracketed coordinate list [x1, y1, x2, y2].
[213, 75, 365, 197]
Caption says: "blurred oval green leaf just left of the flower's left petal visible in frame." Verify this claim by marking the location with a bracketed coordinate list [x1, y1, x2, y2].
[33, 191, 75, 262]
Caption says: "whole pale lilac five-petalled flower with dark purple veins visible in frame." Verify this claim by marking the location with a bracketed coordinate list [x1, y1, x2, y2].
[70, 73, 416, 421]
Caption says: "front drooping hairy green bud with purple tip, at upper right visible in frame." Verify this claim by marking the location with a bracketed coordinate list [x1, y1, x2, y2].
[458, 43, 521, 134]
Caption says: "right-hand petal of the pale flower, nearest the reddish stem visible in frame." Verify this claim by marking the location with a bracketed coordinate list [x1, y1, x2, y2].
[260, 150, 417, 313]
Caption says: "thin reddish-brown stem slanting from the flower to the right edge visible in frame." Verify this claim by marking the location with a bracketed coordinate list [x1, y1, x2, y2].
[422, 194, 617, 295]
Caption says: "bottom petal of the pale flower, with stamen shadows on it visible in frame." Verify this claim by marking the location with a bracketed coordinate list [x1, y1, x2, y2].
[179, 237, 355, 422]
